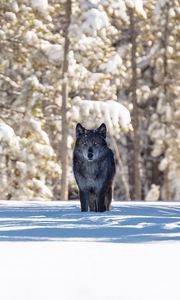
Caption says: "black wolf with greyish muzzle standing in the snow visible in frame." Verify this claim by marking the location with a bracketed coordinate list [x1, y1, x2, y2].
[73, 123, 115, 212]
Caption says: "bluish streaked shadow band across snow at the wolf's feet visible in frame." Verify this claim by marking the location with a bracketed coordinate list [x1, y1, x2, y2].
[0, 202, 180, 243]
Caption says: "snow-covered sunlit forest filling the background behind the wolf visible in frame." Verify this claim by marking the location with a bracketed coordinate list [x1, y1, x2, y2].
[0, 0, 180, 201]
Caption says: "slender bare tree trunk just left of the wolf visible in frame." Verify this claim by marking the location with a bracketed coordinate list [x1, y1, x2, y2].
[61, 0, 71, 200]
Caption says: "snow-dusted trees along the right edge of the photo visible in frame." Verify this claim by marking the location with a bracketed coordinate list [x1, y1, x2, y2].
[148, 0, 180, 200]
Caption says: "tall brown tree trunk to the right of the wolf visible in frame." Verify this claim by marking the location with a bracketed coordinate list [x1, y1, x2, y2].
[130, 9, 141, 200]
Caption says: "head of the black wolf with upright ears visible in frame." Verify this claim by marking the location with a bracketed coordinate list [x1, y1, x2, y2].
[76, 123, 107, 161]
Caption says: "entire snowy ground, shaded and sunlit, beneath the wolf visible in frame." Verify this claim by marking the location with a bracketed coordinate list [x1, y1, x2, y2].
[0, 201, 180, 300]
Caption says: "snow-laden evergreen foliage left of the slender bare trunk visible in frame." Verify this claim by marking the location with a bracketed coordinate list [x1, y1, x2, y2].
[0, 1, 61, 199]
